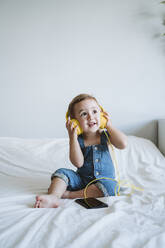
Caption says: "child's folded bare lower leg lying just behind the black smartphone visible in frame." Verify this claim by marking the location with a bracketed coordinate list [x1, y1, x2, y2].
[62, 184, 104, 199]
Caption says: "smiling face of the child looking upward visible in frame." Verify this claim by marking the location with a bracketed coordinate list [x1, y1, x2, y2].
[74, 99, 100, 133]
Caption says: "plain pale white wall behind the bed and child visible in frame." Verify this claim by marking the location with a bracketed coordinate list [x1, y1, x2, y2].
[0, 0, 165, 141]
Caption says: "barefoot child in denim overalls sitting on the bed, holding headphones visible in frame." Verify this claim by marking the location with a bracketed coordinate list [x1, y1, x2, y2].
[35, 94, 127, 208]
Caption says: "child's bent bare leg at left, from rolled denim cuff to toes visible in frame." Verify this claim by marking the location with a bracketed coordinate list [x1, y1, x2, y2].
[34, 177, 67, 208]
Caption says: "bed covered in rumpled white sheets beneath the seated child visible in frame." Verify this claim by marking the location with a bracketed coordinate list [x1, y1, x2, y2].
[0, 120, 165, 248]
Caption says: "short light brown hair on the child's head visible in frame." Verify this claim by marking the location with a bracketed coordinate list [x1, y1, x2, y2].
[67, 94, 99, 119]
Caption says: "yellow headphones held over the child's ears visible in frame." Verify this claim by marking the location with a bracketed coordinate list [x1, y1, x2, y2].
[66, 105, 107, 135]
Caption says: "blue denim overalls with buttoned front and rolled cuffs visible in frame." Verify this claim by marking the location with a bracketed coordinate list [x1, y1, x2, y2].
[51, 132, 118, 196]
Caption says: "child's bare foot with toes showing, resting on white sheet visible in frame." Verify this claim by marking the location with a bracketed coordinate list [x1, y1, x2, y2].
[34, 195, 60, 208]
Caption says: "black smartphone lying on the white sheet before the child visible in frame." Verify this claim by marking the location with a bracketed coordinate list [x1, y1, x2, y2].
[75, 198, 108, 209]
